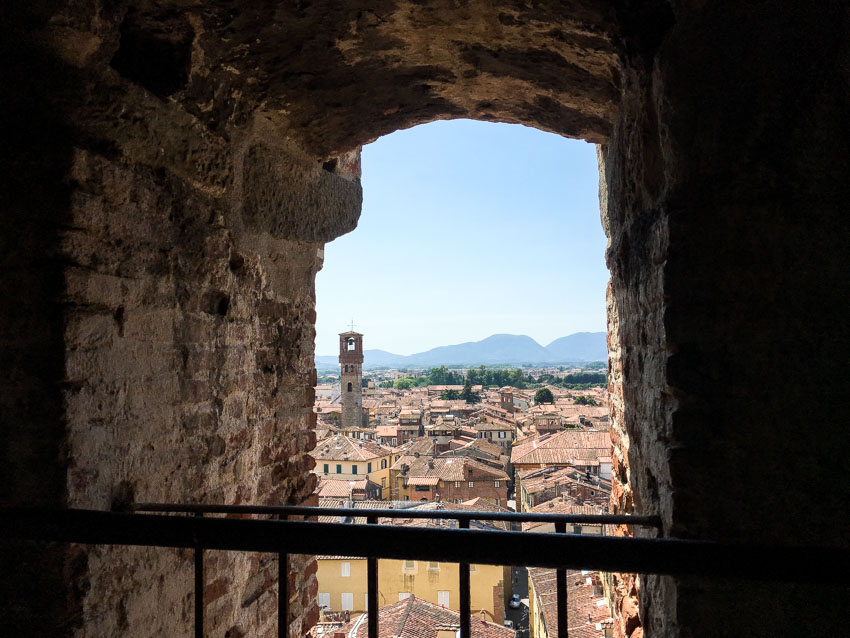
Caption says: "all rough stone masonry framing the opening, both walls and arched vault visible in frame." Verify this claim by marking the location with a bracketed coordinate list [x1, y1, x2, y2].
[0, 0, 850, 638]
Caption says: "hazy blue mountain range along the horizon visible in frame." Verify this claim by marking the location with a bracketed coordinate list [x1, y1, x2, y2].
[316, 332, 608, 370]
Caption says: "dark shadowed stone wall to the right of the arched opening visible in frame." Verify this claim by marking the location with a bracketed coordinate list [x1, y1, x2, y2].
[604, 3, 850, 636]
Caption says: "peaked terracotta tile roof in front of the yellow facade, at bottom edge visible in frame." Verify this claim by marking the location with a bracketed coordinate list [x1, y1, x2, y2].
[339, 596, 514, 638]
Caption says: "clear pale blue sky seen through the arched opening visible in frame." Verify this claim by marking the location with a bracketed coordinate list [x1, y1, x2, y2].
[316, 120, 608, 355]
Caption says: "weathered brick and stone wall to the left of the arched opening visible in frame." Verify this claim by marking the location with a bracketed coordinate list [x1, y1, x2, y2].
[2, 3, 361, 637]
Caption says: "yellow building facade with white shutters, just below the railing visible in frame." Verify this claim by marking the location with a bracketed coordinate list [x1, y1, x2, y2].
[316, 556, 510, 624]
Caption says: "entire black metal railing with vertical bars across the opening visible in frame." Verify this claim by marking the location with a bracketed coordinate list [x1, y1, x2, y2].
[0, 503, 850, 638]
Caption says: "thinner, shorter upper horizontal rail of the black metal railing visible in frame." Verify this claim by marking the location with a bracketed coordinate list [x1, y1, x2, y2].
[133, 503, 661, 528]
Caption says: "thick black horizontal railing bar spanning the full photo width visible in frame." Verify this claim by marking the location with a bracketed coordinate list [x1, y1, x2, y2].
[0, 508, 850, 585]
